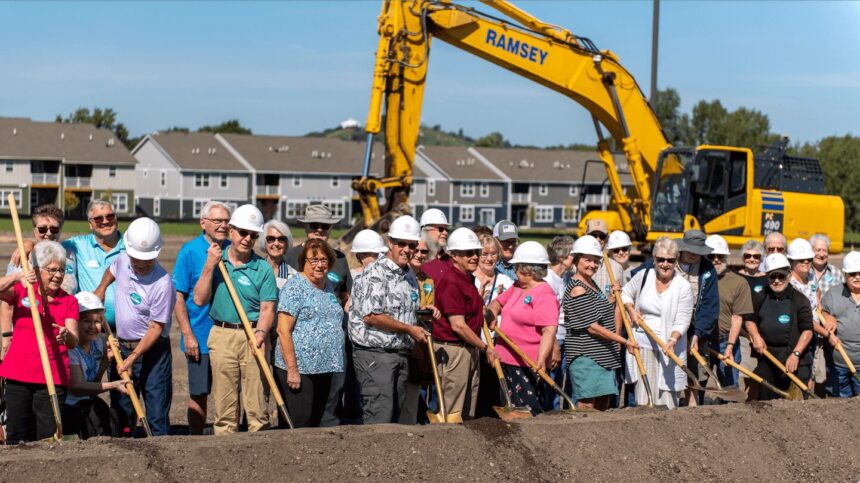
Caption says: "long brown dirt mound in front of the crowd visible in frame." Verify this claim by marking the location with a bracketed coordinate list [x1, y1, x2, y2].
[0, 400, 860, 482]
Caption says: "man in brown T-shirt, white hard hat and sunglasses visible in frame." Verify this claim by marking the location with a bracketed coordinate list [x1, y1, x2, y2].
[703, 235, 752, 387]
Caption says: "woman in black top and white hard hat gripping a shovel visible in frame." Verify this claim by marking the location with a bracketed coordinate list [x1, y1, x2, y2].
[744, 253, 813, 400]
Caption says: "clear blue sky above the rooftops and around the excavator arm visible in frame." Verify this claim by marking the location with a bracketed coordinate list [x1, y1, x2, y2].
[0, 0, 860, 145]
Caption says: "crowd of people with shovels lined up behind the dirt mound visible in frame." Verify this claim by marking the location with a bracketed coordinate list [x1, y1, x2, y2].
[0, 200, 860, 443]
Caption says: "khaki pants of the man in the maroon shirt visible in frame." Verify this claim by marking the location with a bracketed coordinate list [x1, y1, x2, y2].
[435, 342, 481, 419]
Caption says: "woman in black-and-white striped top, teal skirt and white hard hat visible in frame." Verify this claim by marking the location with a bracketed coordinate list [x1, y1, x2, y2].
[562, 235, 639, 411]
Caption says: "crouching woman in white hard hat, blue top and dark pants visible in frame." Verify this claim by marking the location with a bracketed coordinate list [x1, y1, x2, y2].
[62, 292, 127, 439]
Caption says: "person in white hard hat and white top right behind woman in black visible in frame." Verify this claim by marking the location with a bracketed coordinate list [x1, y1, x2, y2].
[786, 238, 827, 397]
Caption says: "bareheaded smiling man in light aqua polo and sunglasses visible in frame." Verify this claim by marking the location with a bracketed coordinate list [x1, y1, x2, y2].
[63, 199, 125, 328]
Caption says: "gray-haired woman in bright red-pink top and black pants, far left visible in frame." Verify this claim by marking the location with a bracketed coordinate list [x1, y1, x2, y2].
[0, 241, 78, 443]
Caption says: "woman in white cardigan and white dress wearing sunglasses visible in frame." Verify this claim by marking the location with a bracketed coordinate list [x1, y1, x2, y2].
[622, 237, 695, 408]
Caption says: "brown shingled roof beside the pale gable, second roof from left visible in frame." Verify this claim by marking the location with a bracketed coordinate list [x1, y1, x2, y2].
[144, 132, 247, 171]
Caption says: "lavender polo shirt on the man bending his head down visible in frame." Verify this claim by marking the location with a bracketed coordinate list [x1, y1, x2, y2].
[110, 252, 176, 340]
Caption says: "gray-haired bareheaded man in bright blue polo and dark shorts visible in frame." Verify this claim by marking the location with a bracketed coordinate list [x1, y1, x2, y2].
[173, 201, 230, 434]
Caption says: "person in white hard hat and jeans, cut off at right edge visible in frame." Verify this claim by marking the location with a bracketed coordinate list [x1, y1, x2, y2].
[821, 251, 860, 397]
